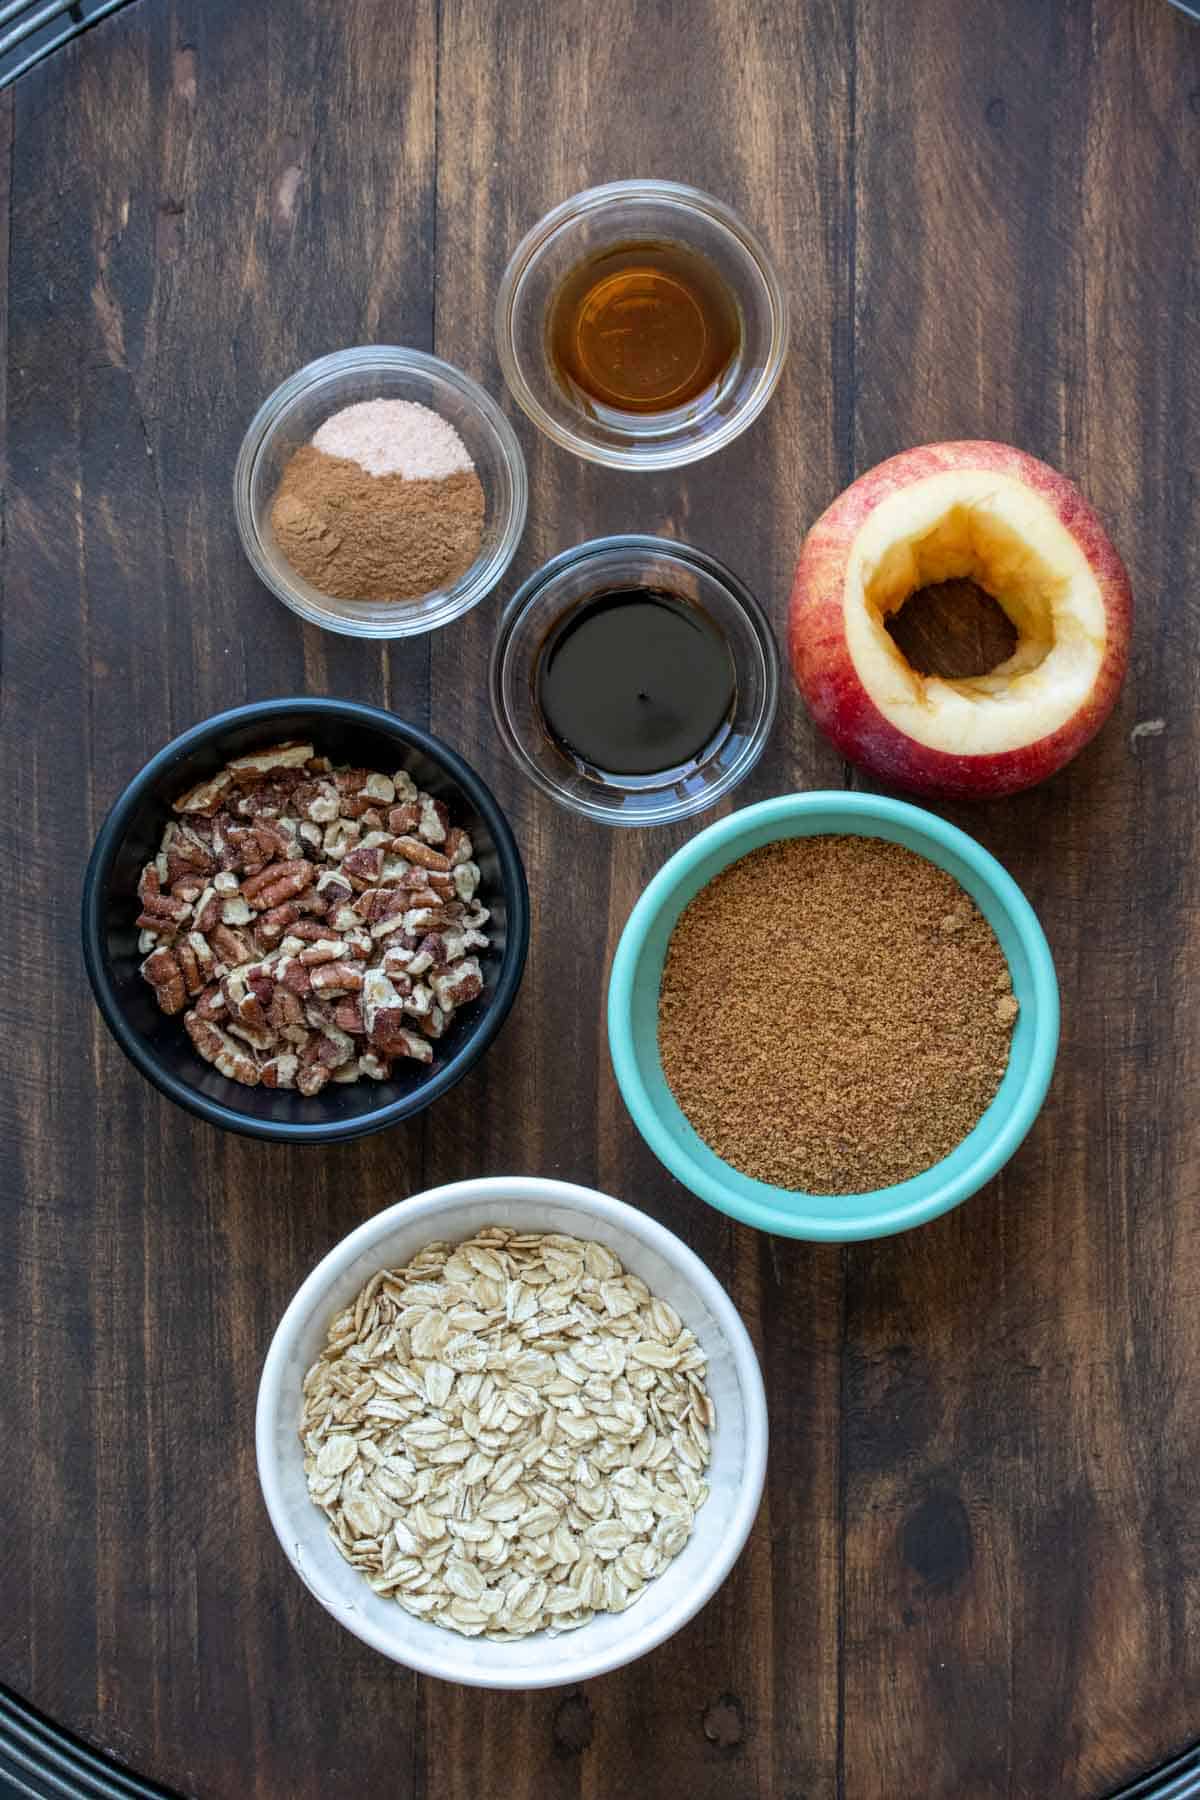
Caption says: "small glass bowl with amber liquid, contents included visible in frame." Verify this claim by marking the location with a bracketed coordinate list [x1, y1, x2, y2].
[497, 182, 788, 470]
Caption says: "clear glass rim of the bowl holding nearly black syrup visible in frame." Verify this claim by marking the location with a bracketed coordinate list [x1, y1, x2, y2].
[488, 531, 779, 830]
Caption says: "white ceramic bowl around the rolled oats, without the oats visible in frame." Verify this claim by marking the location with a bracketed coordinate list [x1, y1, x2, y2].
[257, 1175, 766, 1688]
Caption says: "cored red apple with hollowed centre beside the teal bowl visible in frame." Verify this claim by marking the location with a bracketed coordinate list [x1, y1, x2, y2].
[790, 443, 1133, 799]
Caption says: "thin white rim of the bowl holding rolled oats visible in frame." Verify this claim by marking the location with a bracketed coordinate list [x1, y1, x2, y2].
[254, 1175, 766, 1690]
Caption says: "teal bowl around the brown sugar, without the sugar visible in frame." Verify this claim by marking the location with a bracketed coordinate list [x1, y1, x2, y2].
[608, 794, 1058, 1244]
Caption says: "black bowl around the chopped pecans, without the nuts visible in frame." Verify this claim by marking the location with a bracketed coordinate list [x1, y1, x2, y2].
[83, 698, 529, 1143]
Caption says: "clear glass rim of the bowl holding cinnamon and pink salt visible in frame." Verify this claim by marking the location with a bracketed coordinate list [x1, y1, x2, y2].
[234, 344, 529, 639]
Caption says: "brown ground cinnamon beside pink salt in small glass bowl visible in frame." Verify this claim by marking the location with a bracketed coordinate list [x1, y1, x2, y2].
[270, 445, 486, 599]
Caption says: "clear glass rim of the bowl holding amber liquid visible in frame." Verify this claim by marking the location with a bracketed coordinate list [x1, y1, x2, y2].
[495, 180, 792, 472]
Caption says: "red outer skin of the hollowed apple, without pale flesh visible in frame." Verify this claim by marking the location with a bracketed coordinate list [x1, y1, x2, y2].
[788, 439, 1133, 799]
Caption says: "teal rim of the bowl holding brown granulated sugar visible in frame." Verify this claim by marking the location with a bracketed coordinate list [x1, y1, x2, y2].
[608, 790, 1060, 1244]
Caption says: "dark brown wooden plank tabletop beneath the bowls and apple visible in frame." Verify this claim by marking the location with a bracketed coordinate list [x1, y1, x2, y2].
[0, 0, 1200, 1800]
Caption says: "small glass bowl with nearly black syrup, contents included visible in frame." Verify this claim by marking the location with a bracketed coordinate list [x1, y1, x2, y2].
[491, 536, 779, 824]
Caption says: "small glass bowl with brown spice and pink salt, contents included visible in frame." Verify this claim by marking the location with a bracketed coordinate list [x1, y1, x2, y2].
[234, 344, 529, 637]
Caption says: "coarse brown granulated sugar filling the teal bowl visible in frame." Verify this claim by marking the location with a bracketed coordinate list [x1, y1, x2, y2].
[658, 837, 1018, 1193]
